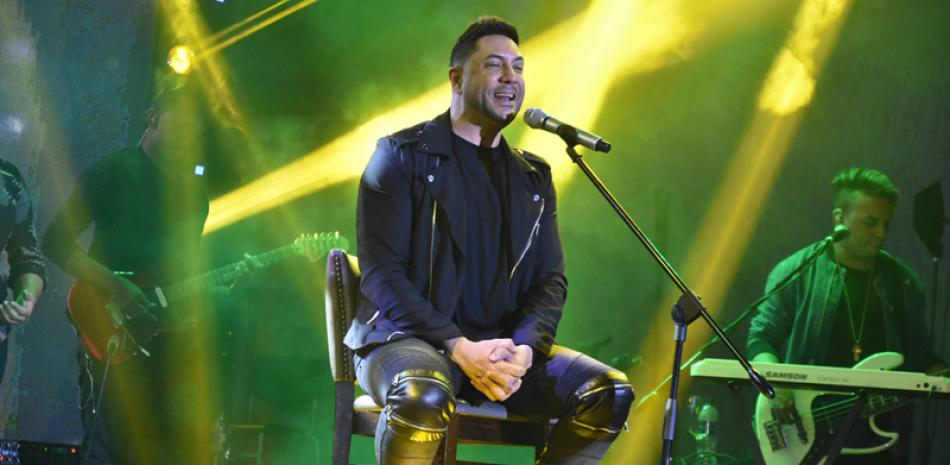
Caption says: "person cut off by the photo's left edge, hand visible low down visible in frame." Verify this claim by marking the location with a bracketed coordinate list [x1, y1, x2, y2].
[0, 159, 45, 379]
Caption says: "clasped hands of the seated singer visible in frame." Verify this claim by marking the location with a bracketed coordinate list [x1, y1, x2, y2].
[446, 337, 533, 401]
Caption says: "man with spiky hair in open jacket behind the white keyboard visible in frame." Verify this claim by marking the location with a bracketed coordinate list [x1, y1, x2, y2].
[747, 168, 942, 464]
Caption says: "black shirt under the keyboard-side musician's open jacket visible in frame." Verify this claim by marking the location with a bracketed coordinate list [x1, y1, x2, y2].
[823, 266, 887, 367]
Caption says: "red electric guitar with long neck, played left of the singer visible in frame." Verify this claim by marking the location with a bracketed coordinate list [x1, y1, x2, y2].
[68, 233, 349, 364]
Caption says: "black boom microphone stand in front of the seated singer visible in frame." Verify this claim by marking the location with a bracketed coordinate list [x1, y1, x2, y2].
[557, 124, 775, 465]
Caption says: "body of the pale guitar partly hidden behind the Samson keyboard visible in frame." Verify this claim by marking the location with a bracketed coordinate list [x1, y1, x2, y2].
[754, 352, 904, 465]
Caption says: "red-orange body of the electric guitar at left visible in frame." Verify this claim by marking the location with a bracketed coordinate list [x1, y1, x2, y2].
[68, 280, 162, 364]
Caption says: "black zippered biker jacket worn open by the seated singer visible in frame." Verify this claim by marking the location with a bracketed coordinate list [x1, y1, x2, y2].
[345, 112, 567, 353]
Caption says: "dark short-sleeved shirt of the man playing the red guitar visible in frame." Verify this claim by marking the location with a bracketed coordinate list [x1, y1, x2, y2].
[43, 147, 208, 281]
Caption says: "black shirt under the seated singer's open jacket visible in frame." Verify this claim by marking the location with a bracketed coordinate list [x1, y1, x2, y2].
[453, 135, 514, 340]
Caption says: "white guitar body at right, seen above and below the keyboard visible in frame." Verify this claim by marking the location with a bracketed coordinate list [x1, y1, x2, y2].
[754, 352, 904, 465]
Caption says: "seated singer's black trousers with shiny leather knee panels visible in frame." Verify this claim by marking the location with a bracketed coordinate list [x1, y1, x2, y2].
[356, 338, 633, 465]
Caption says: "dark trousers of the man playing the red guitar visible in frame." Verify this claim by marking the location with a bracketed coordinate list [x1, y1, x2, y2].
[79, 288, 230, 465]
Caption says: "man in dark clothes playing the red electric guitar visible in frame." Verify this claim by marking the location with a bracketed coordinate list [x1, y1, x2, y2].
[43, 82, 218, 465]
